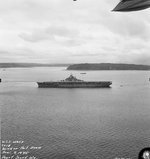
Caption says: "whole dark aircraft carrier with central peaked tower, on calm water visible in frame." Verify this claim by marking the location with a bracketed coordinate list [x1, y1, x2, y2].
[37, 75, 112, 88]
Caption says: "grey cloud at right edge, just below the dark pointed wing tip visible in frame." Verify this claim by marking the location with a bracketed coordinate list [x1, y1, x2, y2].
[97, 14, 150, 40]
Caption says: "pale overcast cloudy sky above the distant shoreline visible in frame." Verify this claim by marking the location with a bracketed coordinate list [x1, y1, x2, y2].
[0, 0, 150, 65]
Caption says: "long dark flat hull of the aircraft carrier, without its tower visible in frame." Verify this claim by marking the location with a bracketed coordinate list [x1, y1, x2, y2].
[37, 81, 112, 88]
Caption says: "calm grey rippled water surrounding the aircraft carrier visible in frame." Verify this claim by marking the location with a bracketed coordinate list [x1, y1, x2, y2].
[0, 67, 150, 159]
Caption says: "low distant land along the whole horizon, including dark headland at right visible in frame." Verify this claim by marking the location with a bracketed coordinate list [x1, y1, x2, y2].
[0, 63, 150, 71]
